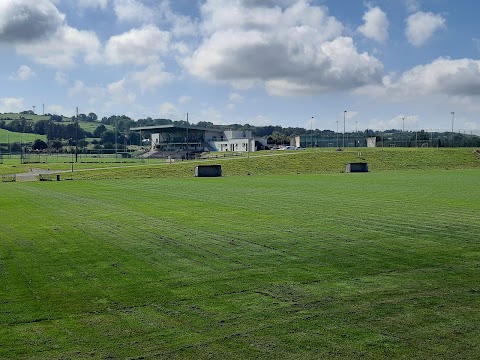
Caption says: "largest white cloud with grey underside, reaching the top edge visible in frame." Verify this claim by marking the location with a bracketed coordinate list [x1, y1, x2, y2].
[183, 0, 383, 95]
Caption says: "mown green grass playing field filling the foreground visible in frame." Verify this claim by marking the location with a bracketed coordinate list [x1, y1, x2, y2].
[0, 169, 480, 359]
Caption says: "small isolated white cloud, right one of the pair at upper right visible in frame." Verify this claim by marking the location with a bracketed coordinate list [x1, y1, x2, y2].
[405, 11, 446, 47]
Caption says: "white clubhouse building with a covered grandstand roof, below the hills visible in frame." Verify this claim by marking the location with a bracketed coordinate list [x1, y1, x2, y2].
[130, 125, 267, 152]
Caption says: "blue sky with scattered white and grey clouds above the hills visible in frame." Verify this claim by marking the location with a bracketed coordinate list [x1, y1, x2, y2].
[0, 0, 480, 132]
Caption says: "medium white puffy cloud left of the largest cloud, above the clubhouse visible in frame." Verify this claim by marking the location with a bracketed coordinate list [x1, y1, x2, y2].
[105, 25, 170, 65]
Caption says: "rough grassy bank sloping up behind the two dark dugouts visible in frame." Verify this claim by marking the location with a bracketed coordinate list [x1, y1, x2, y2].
[63, 148, 480, 179]
